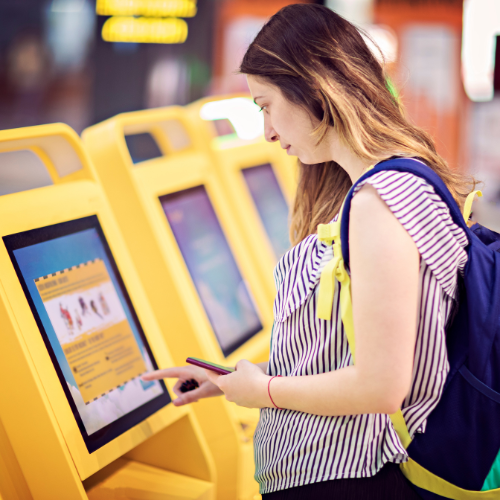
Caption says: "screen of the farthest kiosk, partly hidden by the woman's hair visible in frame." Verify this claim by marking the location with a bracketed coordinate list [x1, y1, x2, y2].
[242, 163, 290, 261]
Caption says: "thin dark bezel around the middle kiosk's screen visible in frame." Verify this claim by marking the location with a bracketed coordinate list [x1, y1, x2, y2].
[159, 184, 264, 358]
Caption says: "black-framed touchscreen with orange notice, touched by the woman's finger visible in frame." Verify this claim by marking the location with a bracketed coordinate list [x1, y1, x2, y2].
[4, 216, 170, 452]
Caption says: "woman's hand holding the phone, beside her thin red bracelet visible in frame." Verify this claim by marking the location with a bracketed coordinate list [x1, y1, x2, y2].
[206, 359, 272, 408]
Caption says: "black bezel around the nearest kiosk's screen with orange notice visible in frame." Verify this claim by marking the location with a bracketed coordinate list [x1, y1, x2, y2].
[3, 215, 172, 453]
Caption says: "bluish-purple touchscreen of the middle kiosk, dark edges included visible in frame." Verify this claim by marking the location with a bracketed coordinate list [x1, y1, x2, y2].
[160, 186, 262, 356]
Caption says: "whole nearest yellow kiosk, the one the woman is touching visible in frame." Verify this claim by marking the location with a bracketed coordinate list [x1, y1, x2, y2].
[0, 125, 215, 500]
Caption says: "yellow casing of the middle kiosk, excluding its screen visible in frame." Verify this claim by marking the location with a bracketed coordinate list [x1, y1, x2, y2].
[82, 107, 272, 500]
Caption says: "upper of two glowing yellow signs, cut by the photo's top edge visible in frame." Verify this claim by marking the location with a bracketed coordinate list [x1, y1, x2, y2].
[96, 0, 196, 17]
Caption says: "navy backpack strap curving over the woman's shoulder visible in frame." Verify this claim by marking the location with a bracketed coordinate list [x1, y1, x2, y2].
[340, 158, 469, 269]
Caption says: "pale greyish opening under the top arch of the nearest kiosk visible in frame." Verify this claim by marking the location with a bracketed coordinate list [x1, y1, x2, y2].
[0, 150, 53, 195]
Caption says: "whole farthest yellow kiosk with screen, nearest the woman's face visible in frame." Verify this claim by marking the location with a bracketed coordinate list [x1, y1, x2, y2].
[187, 96, 298, 299]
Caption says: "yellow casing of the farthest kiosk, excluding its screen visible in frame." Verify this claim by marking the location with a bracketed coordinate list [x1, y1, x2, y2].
[187, 95, 298, 300]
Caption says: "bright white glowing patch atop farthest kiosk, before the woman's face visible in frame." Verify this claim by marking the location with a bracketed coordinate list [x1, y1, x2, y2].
[200, 97, 264, 140]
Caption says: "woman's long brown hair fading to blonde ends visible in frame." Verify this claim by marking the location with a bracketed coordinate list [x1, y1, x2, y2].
[240, 4, 475, 244]
